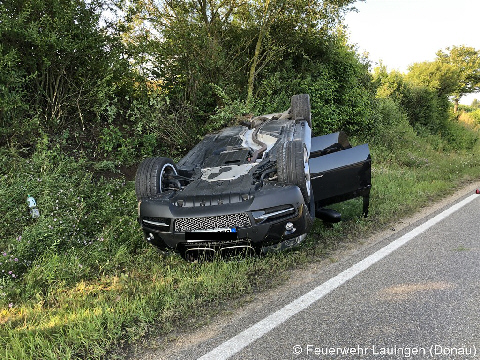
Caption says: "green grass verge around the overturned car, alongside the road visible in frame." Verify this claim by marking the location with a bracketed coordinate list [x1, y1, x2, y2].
[0, 123, 480, 360]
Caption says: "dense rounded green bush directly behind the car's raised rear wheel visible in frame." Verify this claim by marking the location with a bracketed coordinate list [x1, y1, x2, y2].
[251, 34, 375, 134]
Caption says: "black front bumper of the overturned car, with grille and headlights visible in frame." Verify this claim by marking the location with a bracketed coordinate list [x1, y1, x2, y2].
[139, 185, 311, 252]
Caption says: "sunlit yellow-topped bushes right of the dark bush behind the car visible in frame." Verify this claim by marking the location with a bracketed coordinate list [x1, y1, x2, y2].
[373, 63, 478, 152]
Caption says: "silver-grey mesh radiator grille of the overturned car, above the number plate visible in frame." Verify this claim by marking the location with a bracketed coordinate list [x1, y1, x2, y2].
[175, 213, 251, 232]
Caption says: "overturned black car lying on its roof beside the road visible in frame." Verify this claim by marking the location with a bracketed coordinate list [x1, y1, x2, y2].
[135, 94, 371, 260]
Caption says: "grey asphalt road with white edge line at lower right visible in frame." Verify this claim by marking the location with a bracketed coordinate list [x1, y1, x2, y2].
[146, 193, 480, 360]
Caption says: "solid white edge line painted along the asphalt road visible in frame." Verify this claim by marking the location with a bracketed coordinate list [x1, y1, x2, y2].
[198, 195, 478, 360]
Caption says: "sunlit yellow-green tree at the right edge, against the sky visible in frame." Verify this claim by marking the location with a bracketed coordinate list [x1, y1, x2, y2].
[436, 45, 480, 112]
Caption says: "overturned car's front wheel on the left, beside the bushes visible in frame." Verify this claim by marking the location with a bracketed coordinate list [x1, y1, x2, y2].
[135, 157, 177, 200]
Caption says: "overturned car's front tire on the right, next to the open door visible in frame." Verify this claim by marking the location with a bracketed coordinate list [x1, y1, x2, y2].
[277, 140, 313, 206]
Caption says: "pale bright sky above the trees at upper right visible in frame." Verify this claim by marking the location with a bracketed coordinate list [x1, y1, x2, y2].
[345, 0, 480, 105]
